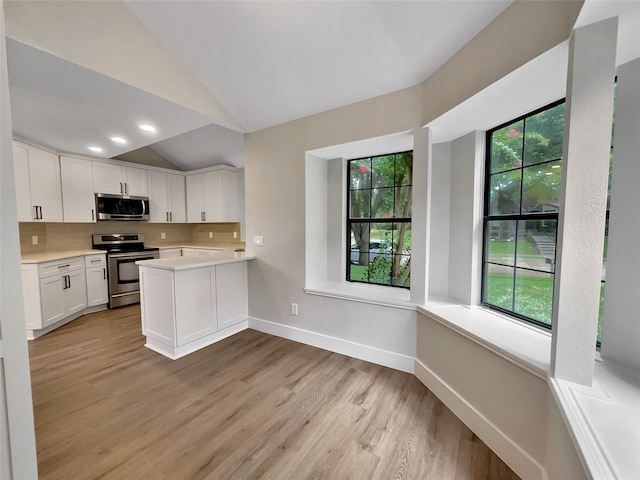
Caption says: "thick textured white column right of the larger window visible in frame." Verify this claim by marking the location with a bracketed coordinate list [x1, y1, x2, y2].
[551, 18, 618, 385]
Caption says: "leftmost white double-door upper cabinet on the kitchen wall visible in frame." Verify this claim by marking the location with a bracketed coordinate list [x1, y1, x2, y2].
[13, 142, 63, 222]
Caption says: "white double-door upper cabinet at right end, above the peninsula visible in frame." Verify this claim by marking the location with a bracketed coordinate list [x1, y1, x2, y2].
[187, 169, 239, 223]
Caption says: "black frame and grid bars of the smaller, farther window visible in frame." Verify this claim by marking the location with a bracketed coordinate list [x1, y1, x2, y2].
[345, 150, 413, 289]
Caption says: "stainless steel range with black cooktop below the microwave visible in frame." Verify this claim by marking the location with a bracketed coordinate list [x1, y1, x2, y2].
[93, 233, 159, 308]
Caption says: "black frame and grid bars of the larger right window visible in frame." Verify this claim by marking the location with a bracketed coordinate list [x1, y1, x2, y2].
[480, 98, 566, 330]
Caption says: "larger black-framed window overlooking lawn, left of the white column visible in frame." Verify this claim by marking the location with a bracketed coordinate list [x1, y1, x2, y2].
[482, 101, 564, 326]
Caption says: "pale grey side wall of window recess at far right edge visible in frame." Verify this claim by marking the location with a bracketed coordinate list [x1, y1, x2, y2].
[600, 59, 640, 370]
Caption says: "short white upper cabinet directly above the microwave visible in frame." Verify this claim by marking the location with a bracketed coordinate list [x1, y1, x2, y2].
[93, 162, 147, 197]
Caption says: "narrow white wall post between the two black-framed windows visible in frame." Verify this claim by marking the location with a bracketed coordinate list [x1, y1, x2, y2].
[411, 127, 433, 305]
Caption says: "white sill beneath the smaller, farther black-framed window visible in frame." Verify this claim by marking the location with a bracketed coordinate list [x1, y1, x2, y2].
[304, 282, 416, 310]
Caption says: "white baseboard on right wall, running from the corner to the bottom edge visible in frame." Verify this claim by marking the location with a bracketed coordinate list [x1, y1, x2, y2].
[414, 359, 548, 480]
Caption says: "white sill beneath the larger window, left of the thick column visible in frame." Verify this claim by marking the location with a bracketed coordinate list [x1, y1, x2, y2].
[417, 299, 551, 380]
